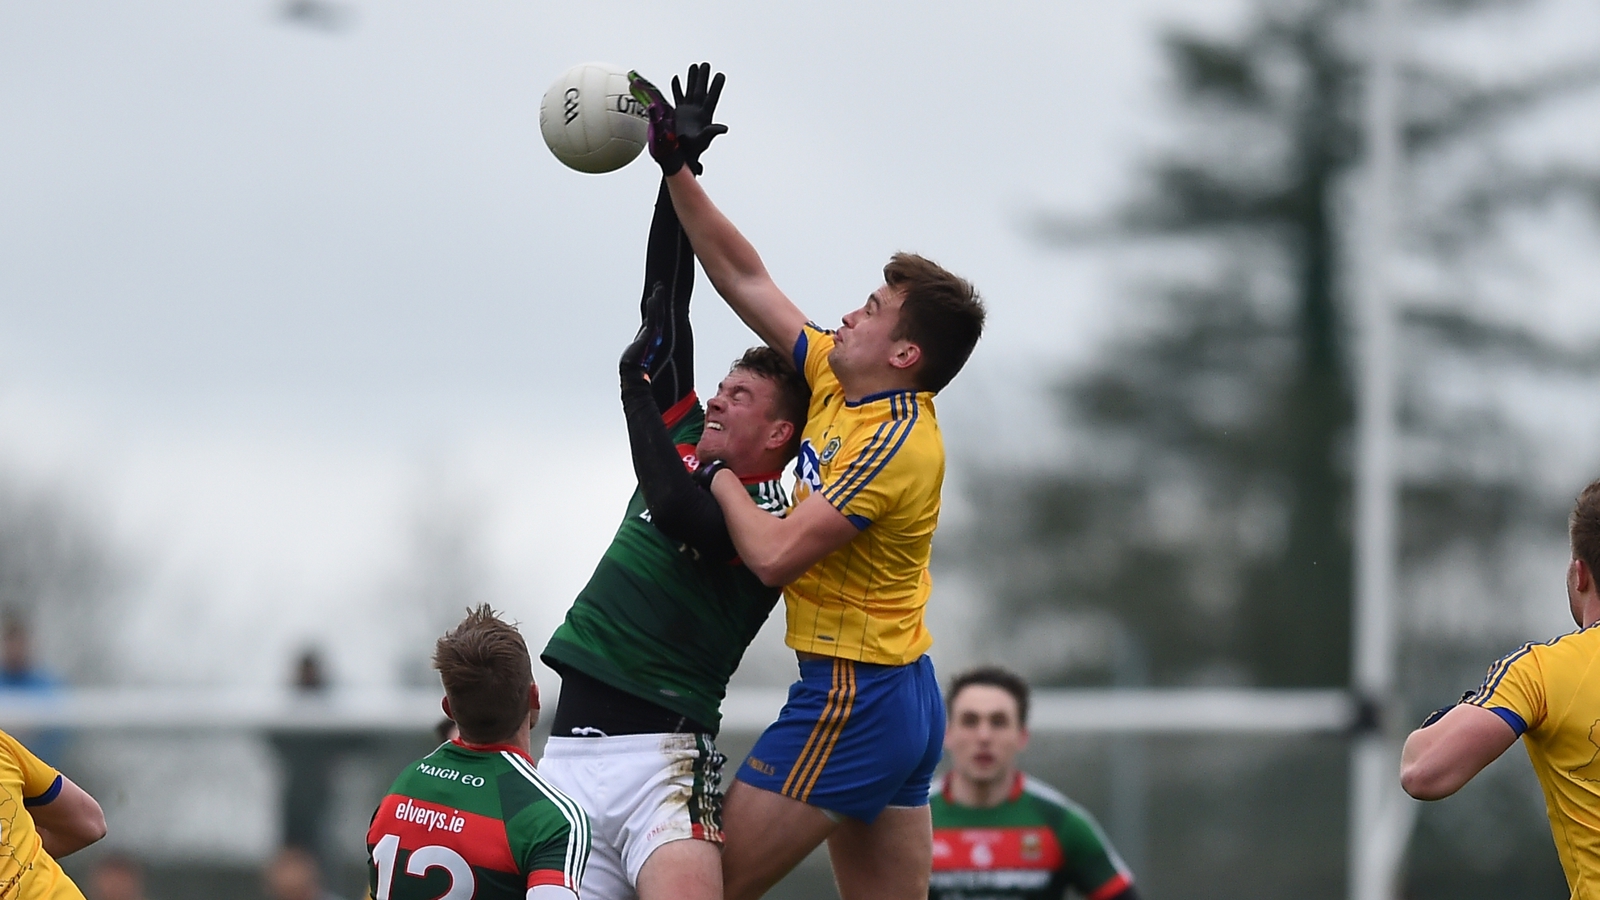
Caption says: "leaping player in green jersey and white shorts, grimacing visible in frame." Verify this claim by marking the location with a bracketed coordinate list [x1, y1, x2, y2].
[541, 66, 806, 900]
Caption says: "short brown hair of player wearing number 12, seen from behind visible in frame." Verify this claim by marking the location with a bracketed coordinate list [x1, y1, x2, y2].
[434, 604, 533, 743]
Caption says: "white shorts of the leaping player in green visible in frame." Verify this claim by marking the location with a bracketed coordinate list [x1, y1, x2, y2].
[539, 733, 725, 900]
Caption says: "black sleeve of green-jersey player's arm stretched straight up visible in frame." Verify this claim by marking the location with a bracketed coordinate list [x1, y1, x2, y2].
[640, 179, 694, 410]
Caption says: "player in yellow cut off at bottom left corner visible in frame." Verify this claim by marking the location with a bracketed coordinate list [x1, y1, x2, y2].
[0, 732, 106, 900]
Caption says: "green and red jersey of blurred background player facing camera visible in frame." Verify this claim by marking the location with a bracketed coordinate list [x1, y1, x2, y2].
[928, 772, 1133, 900]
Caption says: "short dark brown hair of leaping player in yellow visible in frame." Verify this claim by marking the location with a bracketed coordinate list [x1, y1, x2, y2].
[883, 253, 984, 391]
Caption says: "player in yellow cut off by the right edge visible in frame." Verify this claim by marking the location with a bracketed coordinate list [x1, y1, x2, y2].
[1400, 480, 1600, 898]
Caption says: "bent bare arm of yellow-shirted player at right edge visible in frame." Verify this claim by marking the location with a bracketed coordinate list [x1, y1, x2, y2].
[1400, 703, 1517, 801]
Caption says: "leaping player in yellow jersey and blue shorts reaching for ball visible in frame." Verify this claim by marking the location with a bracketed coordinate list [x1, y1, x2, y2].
[634, 64, 984, 900]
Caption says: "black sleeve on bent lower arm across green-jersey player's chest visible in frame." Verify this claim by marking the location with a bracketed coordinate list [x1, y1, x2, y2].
[622, 374, 739, 562]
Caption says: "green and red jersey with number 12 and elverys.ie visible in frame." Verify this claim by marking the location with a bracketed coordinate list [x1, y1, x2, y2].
[366, 741, 589, 900]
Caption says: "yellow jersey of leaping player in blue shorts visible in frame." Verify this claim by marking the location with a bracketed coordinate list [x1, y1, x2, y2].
[784, 323, 944, 666]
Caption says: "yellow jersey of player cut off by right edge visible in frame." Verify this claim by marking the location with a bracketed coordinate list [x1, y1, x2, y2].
[1467, 626, 1600, 898]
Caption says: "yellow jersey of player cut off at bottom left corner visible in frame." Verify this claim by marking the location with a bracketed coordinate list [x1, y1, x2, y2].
[0, 732, 83, 900]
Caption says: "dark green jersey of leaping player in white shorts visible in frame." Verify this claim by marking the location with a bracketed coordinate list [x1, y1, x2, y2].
[539, 394, 787, 732]
